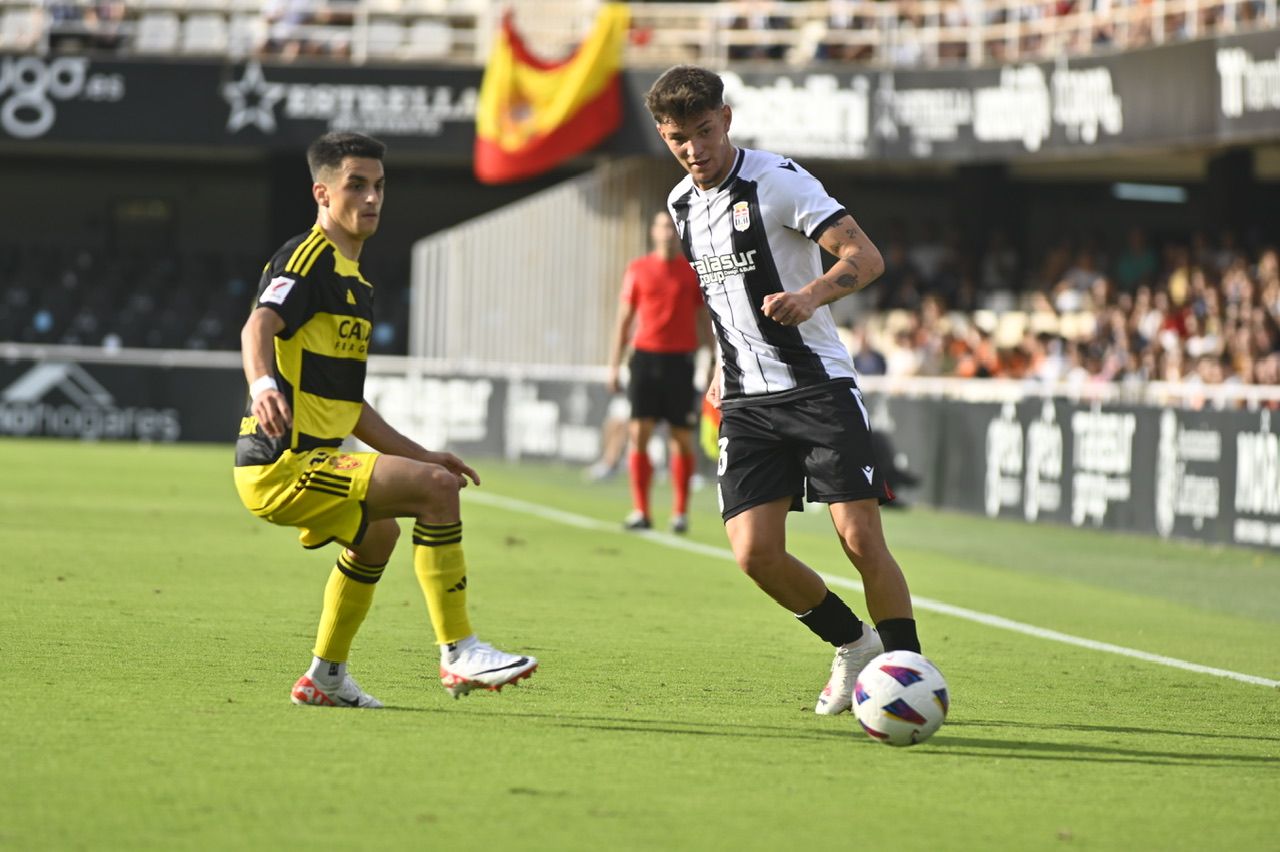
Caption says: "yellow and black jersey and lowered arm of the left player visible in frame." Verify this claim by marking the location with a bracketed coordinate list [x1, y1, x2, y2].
[236, 225, 374, 466]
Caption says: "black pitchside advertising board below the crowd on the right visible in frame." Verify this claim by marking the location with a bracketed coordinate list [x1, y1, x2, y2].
[870, 395, 1280, 548]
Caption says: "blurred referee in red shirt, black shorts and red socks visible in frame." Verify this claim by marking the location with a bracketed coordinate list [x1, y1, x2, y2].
[608, 211, 712, 532]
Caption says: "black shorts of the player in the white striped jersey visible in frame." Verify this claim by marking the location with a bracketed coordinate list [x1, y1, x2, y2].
[717, 386, 893, 521]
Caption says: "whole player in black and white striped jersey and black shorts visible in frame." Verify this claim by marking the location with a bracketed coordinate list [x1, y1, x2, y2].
[645, 65, 920, 715]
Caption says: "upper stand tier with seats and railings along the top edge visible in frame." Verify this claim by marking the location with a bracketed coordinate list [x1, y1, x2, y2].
[0, 0, 1277, 68]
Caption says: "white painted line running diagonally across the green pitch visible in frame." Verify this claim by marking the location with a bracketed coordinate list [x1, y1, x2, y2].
[466, 489, 1280, 688]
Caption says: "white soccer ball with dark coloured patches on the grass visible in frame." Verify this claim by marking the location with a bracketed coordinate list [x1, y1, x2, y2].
[854, 651, 950, 746]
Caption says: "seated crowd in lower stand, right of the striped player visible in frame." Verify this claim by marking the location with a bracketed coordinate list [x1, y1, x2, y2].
[841, 220, 1280, 396]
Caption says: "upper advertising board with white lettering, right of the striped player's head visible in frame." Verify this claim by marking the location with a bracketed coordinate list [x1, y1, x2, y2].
[627, 31, 1280, 161]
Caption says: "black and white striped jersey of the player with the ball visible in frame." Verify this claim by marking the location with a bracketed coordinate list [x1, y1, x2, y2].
[667, 148, 856, 408]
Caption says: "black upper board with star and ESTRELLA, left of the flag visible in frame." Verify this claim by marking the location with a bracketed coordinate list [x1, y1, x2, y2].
[0, 55, 480, 153]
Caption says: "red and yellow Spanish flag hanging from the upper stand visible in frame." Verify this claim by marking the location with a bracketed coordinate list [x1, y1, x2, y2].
[475, 3, 630, 183]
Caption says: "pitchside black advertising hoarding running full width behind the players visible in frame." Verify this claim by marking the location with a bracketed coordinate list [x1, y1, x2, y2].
[0, 358, 1280, 549]
